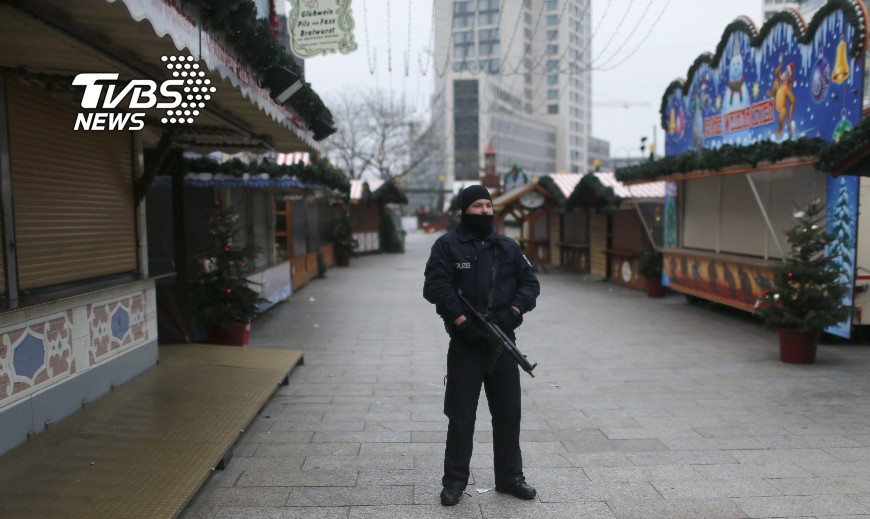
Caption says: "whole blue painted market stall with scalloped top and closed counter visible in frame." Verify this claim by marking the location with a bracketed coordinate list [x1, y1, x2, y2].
[617, 0, 870, 336]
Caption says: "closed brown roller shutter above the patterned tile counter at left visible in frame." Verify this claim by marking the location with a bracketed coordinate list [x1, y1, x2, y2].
[7, 79, 137, 290]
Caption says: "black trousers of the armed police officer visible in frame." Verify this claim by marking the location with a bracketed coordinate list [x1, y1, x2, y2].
[441, 339, 525, 490]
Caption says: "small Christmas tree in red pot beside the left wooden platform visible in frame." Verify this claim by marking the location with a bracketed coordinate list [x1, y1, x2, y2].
[190, 202, 265, 346]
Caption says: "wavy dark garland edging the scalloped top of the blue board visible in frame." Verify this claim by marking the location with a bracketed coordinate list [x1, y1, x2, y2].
[659, 0, 867, 129]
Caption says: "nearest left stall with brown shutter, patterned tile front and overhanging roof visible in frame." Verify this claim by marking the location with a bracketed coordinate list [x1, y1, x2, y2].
[0, 0, 331, 452]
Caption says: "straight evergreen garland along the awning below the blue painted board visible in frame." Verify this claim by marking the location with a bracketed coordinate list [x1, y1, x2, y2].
[616, 137, 828, 182]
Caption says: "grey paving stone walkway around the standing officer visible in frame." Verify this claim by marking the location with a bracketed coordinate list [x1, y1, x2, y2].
[182, 233, 870, 519]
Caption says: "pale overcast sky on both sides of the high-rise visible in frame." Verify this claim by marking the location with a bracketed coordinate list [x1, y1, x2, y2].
[305, 0, 762, 166]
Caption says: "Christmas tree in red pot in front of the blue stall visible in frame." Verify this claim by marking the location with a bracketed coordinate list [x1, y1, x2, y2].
[755, 200, 849, 364]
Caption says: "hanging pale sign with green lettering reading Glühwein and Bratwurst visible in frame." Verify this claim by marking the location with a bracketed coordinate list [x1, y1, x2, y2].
[287, 0, 357, 58]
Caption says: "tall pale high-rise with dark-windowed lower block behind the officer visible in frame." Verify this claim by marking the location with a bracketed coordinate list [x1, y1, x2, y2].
[432, 0, 592, 191]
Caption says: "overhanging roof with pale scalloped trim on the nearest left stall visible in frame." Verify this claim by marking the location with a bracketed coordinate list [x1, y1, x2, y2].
[0, 0, 317, 152]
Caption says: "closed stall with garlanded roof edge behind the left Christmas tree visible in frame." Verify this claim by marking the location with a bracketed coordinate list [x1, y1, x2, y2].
[147, 156, 348, 342]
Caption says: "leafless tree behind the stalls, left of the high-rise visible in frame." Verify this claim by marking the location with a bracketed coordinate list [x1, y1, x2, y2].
[324, 91, 437, 181]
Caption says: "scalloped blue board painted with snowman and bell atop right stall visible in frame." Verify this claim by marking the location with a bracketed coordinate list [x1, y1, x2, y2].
[661, 1, 867, 155]
